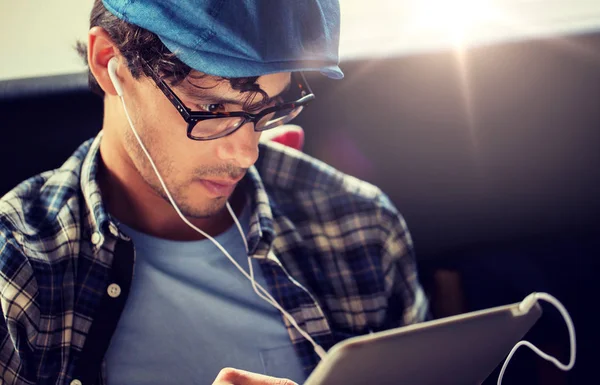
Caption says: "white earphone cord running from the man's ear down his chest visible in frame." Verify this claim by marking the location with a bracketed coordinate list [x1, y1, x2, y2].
[108, 58, 327, 359]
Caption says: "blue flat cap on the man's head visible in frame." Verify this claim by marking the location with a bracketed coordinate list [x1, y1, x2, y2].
[103, 0, 344, 79]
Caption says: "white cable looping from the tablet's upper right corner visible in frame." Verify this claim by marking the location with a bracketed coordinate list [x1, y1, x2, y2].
[498, 293, 576, 385]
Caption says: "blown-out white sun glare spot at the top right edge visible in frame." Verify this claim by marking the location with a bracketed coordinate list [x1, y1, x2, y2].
[413, 0, 498, 44]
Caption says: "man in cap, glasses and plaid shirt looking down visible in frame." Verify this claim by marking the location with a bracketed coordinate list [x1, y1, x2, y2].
[0, 0, 428, 385]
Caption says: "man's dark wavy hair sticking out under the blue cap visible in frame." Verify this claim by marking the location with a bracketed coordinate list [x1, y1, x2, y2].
[76, 0, 268, 107]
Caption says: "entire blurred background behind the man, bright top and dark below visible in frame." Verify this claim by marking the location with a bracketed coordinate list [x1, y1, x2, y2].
[0, 0, 600, 385]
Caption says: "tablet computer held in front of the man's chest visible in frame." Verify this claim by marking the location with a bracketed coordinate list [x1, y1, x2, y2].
[304, 303, 542, 385]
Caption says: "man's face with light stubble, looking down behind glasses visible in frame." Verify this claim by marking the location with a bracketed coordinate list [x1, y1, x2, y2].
[120, 69, 290, 218]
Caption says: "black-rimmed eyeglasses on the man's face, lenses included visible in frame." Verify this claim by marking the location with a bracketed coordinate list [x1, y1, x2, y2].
[145, 63, 315, 141]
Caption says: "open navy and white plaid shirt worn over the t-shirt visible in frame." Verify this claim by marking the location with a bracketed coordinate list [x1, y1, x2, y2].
[0, 134, 428, 385]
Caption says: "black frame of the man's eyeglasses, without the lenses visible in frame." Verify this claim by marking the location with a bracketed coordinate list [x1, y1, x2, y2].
[144, 63, 315, 141]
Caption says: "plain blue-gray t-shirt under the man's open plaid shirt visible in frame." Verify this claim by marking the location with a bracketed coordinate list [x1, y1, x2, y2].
[106, 209, 306, 385]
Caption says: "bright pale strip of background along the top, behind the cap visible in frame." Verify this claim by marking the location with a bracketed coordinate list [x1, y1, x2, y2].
[0, 0, 600, 79]
